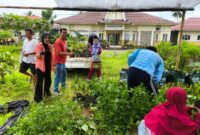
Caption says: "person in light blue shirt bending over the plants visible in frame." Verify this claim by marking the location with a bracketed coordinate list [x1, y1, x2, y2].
[128, 46, 164, 95]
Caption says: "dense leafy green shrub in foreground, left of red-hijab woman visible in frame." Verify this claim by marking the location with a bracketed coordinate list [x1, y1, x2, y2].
[90, 80, 154, 135]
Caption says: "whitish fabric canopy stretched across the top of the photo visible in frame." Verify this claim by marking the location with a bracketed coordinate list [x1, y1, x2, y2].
[55, 0, 200, 11]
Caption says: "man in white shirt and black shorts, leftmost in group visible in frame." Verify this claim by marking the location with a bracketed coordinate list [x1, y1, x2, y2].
[19, 29, 38, 80]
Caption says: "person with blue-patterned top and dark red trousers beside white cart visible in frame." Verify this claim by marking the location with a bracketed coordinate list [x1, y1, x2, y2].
[87, 36, 102, 80]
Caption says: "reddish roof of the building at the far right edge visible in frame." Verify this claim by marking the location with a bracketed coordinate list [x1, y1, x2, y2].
[172, 18, 200, 31]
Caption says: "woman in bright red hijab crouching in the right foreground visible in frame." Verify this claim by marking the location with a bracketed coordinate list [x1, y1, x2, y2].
[138, 87, 200, 135]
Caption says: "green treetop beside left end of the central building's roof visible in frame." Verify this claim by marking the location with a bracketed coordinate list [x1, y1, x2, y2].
[41, 9, 56, 24]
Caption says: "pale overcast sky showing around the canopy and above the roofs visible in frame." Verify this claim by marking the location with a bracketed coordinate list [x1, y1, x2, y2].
[0, 0, 200, 21]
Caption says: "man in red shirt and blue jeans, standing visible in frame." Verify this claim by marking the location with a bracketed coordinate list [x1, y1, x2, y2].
[54, 28, 73, 95]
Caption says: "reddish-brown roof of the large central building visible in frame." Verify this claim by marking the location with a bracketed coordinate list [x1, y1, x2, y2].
[55, 12, 175, 25]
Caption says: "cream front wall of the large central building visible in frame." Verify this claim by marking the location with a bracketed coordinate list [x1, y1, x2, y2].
[61, 24, 171, 45]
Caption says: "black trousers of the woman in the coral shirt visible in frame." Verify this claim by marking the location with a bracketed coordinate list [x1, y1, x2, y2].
[34, 69, 51, 102]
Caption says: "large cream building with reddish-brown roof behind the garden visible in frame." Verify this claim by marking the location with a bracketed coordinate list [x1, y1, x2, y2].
[55, 12, 176, 46]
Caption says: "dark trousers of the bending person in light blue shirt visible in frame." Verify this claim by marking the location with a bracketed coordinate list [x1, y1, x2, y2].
[128, 67, 158, 95]
